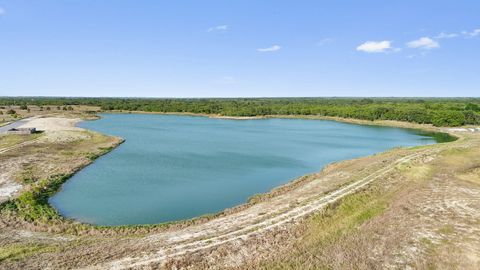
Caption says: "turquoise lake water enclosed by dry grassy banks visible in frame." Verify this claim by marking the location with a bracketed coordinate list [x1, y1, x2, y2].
[50, 114, 435, 225]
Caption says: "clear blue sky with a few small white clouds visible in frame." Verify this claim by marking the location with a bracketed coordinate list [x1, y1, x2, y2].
[0, 0, 480, 97]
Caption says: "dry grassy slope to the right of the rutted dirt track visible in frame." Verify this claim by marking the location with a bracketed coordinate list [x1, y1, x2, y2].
[248, 134, 480, 269]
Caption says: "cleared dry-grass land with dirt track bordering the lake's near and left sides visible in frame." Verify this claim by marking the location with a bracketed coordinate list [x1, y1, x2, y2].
[0, 110, 480, 269]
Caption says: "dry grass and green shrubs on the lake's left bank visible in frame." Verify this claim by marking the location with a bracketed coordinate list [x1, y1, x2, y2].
[0, 131, 121, 231]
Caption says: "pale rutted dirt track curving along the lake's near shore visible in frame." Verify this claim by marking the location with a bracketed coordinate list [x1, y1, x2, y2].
[84, 147, 439, 269]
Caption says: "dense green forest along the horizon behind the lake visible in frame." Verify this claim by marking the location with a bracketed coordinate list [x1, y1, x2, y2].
[0, 97, 480, 126]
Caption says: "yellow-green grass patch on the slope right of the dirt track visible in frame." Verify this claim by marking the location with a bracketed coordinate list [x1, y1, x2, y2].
[259, 187, 391, 269]
